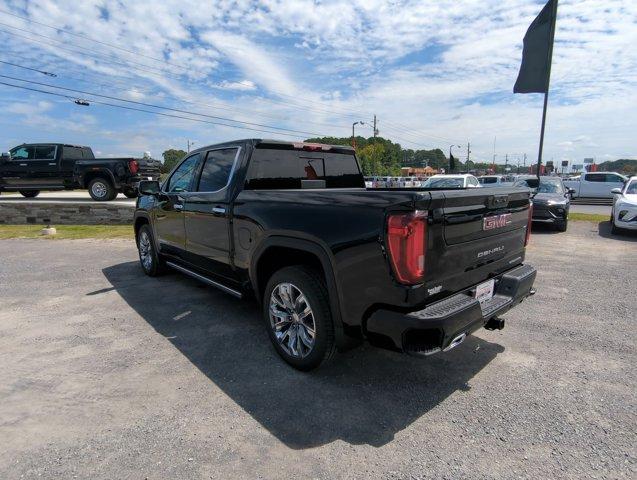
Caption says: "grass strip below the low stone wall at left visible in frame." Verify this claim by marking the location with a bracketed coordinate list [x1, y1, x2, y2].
[0, 225, 134, 240]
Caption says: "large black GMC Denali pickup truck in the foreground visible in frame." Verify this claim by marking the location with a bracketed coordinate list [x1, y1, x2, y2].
[135, 139, 535, 370]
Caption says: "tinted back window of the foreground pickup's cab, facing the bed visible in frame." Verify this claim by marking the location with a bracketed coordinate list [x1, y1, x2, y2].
[246, 148, 365, 190]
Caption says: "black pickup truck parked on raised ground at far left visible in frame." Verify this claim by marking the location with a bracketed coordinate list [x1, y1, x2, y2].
[0, 143, 161, 201]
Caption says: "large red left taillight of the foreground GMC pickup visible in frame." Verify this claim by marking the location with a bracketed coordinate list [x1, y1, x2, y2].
[387, 211, 427, 285]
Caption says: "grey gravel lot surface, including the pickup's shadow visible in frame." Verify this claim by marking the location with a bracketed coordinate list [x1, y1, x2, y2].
[0, 222, 637, 479]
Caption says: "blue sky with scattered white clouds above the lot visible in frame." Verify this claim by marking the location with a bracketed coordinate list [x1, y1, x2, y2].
[0, 0, 637, 169]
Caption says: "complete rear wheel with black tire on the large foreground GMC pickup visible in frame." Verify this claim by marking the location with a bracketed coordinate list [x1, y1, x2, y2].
[263, 265, 336, 371]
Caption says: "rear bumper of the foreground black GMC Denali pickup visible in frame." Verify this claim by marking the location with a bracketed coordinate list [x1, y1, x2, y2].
[366, 265, 536, 355]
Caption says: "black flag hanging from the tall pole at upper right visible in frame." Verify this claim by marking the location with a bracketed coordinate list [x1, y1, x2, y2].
[513, 0, 557, 93]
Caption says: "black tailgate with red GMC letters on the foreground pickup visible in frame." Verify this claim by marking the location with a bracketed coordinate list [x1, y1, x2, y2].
[416, 188, 529, 296]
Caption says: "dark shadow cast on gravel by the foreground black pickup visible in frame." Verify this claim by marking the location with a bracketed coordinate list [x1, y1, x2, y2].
[103, 262, 504, 449]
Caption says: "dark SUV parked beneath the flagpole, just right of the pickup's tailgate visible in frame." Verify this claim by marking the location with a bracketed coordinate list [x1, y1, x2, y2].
[515, 176, 571, 232]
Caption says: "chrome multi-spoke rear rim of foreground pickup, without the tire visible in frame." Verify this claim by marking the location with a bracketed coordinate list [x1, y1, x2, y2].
[270, 283, 316, 358]
